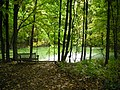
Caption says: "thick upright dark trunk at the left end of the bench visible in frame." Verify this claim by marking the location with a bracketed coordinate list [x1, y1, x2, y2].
[13, 0, 19, 60]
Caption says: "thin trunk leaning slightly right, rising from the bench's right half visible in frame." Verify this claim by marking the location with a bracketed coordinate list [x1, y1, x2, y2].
[30, 0, 37, 60]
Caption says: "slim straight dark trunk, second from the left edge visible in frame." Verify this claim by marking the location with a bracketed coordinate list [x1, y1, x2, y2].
[6, 0, 10, 62]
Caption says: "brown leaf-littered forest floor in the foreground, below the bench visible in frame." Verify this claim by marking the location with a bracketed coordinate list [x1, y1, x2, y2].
[0, 62, 102, 90]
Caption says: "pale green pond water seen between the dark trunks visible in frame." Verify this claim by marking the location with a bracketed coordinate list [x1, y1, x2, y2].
[0, 46, 113, 62]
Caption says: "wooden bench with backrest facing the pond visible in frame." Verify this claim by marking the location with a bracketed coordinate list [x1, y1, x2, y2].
[17, 53, 39, 61]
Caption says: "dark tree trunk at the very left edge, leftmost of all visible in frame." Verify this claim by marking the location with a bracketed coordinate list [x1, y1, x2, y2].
[0, 0, 5, 62]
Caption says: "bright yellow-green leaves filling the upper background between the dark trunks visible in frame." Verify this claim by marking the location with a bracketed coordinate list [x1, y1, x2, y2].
[0, 0, 119, 50]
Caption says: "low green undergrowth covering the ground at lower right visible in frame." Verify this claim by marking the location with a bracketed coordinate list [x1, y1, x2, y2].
[60, 60, 120, 90]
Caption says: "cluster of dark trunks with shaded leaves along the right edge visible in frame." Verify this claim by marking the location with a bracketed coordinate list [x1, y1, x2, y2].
[105, 0, 120, 65]
